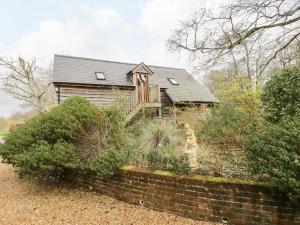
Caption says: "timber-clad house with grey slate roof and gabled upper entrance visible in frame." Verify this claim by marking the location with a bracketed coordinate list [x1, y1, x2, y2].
[53, 55, 218, 119]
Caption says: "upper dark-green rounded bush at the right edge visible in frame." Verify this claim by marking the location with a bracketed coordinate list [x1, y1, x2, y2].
[261, 67, 300, 123]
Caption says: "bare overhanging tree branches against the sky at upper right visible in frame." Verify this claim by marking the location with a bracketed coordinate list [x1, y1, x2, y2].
[167, 0, 300, 89]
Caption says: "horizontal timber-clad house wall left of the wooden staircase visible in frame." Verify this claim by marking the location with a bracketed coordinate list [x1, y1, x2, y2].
[57, 86, 134, 106]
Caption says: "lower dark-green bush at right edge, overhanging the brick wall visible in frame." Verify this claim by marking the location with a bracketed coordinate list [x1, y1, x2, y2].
[246, 116, 300, 199]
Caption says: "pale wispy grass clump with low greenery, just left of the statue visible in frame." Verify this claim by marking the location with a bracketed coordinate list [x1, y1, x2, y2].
[130, 120, 191, 174]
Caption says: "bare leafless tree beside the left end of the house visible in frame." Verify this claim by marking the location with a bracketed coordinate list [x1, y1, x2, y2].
[0, 57, 54, 111]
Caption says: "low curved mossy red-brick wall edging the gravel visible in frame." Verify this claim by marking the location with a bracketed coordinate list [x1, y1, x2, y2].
[68, 166, 300, 225]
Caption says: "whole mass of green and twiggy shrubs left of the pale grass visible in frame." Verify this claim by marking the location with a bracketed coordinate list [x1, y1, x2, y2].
[0, 97, 129, 180]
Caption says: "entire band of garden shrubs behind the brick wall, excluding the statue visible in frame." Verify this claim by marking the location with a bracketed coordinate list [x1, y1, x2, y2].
[0, 65, 300, 199]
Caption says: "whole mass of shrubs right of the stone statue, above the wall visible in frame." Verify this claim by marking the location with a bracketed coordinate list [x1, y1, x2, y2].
[197, 67, 300, 199]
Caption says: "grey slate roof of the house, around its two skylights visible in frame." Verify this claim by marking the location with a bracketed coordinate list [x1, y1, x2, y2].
[53, 55, 218, 102]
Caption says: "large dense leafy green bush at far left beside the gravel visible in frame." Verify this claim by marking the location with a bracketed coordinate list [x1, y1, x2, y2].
[0, 97, 98, 178]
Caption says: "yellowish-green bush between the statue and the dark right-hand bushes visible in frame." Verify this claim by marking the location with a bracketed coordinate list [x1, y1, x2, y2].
[196, 103, 254, 146]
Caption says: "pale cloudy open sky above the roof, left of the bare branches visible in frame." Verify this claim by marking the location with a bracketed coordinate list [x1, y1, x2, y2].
[0, 0, 225, 116]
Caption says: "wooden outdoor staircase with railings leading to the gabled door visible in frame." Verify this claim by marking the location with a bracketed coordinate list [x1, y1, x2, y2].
[125, 85, 161, 124]
